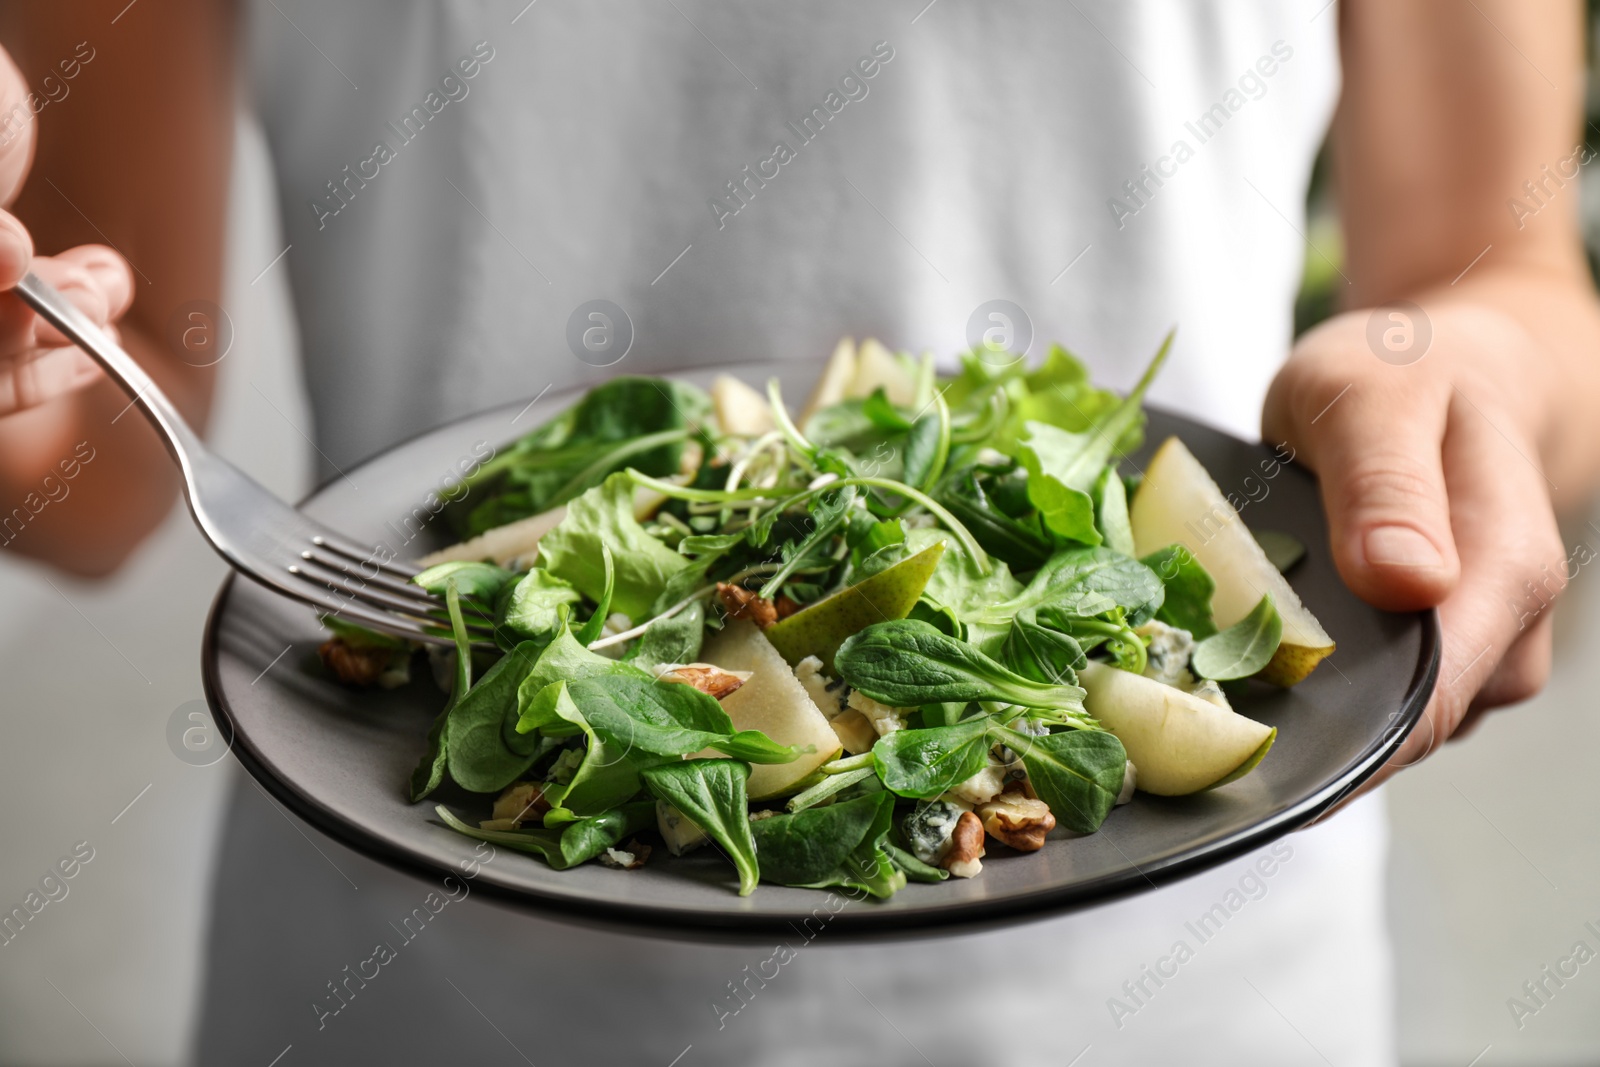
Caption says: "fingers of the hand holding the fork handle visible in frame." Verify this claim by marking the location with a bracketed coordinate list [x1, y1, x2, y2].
[0, 50, 133, 418]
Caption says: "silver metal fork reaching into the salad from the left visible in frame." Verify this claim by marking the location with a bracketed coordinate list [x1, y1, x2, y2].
[16, 272, 494, 645]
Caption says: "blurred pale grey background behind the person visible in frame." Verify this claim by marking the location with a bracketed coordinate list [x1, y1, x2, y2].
[0, 0, 1600, 1067]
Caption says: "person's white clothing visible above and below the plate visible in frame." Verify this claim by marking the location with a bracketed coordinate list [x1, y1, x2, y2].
[202, 0, 1394, 1067]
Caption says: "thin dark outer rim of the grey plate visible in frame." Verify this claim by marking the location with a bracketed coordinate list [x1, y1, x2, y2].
[200, 383, 1442, 941]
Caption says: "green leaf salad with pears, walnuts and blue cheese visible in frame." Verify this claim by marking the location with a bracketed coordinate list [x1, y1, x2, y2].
[322, 329, 1334, 897]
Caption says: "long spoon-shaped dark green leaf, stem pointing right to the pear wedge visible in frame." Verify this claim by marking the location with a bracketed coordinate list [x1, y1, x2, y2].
[834, 619, 1091, 725]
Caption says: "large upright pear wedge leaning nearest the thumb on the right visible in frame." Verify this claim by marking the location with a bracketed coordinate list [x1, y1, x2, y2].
[1128, 437, 1334, 686]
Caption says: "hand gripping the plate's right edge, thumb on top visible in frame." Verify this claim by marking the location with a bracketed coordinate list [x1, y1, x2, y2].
[1262, 278, 1586, 784]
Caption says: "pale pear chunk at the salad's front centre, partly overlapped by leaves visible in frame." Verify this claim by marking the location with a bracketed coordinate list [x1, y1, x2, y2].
[696, 619, 838, 800]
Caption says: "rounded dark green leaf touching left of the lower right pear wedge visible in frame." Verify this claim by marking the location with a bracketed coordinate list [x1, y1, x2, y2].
[994, 726, 1128, 833]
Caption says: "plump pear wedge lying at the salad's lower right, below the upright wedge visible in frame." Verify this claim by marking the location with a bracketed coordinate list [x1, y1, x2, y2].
[1078, 662, 1278, 797]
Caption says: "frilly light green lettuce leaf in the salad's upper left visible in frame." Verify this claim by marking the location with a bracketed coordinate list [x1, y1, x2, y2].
[539, 474, 690, 619]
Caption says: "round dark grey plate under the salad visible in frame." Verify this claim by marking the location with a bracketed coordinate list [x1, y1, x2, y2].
[203, 365, 1438, 936]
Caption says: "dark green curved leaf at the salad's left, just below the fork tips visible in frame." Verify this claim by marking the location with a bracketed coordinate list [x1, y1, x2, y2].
[443, 641, 542, 793]
